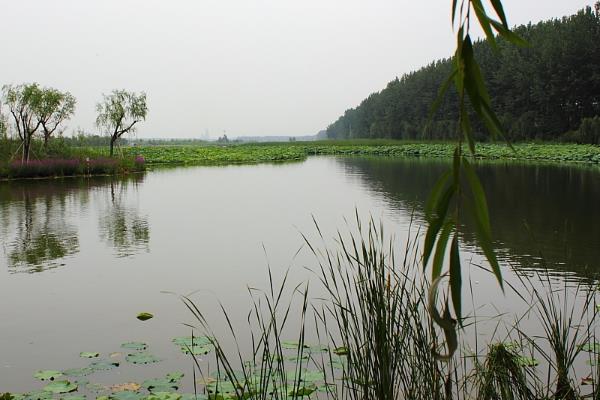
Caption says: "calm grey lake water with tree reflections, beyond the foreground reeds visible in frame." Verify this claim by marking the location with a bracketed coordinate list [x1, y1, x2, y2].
[0, 157, 600, 392]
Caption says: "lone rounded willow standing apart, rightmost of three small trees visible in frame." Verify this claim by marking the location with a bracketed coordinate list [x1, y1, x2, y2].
[96, 90, 148, 157]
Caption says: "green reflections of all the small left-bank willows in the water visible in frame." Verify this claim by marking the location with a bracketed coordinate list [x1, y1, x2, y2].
[0, 175, 150, 273]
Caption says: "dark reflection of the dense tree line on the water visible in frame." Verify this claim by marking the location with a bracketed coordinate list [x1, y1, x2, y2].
[339, 158, 600, 277]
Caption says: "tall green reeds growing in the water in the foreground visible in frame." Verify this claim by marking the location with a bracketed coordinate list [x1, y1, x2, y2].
[183, 218, 600, 400]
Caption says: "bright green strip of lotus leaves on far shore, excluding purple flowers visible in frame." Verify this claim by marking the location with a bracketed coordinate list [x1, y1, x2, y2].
[116, 140, 600, 165]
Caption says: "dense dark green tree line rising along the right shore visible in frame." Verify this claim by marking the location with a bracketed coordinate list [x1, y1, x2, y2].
[327, 2, 600, 143]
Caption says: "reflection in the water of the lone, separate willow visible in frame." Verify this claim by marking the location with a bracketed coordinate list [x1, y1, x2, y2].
[99, 181, 150, 257]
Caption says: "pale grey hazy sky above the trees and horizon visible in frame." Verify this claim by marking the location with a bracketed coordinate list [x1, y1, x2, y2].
[0, 0, 593, 138]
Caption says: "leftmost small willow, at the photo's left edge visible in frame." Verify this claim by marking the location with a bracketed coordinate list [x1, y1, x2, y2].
[2, 83, 43, 163]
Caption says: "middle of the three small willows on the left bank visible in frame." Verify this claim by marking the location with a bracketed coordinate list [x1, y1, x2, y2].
[36, 88, 76, 148]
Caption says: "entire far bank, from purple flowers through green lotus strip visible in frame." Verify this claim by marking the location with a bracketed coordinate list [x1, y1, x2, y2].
[0, 140, 600, 179]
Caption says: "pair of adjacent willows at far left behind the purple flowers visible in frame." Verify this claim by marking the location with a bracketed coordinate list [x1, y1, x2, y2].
[0, 83, 76, 162]
